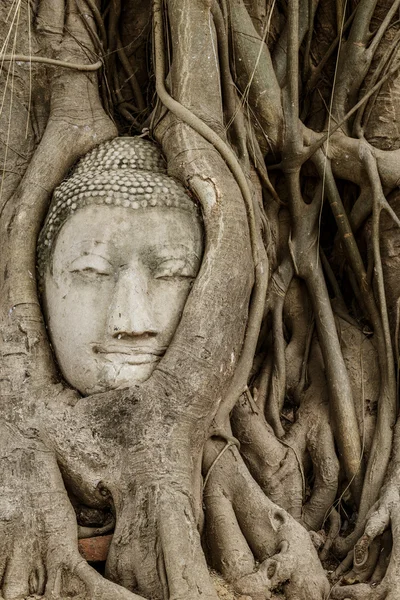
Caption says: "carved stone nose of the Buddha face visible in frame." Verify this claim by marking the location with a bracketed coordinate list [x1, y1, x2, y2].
[108, 269, 158, 338]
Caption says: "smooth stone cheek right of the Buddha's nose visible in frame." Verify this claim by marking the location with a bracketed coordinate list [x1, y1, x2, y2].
[152, 280, 191, 339]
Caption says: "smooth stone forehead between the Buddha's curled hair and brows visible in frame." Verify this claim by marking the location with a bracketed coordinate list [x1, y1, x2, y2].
[53, 205, 202, 260]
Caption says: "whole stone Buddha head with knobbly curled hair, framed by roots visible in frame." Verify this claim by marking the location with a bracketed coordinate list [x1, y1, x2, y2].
[38, 138, 203, 395]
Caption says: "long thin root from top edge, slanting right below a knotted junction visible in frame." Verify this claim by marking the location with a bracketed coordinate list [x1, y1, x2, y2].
[282, 5, 363, 502]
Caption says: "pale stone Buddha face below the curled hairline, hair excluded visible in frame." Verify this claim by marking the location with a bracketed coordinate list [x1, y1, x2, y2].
[44, 205, 202, 395]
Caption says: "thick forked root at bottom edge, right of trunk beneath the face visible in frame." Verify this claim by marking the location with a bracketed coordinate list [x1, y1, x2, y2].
[204, 441, 329, 600]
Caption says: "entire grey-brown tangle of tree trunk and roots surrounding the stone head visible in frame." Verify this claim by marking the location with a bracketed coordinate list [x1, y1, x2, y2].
[0, 0, 400, 600]
